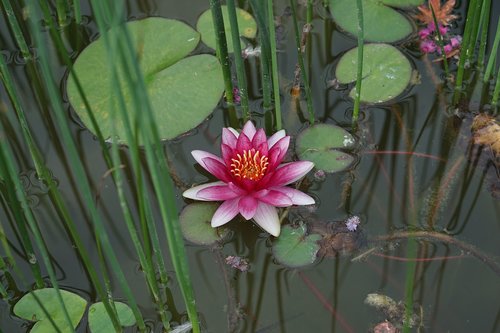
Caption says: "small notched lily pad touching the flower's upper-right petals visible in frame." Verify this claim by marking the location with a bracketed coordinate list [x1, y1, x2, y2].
[295, 124, 356, 172]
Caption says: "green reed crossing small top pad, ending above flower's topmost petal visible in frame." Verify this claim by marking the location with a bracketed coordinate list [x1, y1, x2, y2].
[226, 0, 250, 122]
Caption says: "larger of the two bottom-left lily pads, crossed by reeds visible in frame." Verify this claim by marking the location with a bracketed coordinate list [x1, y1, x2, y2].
[14, 288, 87, 333]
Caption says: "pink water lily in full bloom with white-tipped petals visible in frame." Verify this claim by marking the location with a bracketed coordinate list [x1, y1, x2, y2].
[182, 121, 314, 237]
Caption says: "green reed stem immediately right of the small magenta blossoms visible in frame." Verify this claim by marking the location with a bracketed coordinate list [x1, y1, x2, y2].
[453, 0, 481, 105]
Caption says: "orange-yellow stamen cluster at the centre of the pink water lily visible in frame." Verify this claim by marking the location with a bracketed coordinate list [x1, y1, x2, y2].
[230, 148, 269, 180]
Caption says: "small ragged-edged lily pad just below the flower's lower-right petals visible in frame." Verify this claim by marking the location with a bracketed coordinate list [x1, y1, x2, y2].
[273, 223, 321, 267]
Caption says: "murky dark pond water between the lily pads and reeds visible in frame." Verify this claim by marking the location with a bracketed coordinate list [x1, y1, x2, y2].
[0, 0, 500, 333]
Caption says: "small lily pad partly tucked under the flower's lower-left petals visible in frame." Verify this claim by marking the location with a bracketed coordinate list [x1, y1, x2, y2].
[179, 202, 229, 245]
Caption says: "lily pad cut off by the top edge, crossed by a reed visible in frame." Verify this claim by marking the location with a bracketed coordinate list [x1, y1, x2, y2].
[330, 0, 424, 43]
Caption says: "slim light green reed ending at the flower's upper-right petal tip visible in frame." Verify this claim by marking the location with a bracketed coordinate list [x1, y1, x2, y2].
[267, 1, 282, 130]
